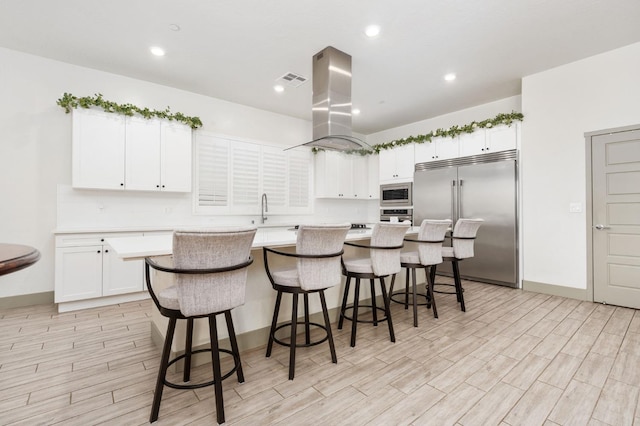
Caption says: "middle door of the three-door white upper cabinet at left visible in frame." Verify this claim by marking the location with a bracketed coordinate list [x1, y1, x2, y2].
[125, 117, 160, 191]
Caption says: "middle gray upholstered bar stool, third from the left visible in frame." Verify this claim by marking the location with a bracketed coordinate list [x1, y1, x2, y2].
[338, 223, 411, 347]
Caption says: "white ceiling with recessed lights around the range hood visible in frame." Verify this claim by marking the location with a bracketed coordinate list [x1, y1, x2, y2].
[0, 0, 640, 135]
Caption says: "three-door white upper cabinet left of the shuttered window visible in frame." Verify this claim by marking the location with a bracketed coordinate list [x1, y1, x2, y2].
[72, 109, 191, 192]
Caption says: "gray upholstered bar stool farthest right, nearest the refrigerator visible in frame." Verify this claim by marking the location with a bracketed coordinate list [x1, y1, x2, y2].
[431, 219, 484, 312]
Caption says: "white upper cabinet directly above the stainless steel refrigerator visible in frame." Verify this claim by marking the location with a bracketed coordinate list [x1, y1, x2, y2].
[460, 123, 519, 157]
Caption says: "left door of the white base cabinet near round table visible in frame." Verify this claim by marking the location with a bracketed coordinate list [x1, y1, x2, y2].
[55, 245, 102, 303]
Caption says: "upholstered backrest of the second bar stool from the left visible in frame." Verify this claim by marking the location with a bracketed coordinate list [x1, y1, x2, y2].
[296, 223, 351, 291]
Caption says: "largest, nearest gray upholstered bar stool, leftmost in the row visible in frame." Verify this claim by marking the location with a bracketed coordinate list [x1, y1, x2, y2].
[145, 227, 256, 423]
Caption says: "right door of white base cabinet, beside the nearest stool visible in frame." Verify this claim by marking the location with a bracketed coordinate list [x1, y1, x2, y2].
[102, 245, 144, 296]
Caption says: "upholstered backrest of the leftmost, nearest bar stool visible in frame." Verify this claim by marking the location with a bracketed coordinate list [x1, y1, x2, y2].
[173, 227, 256, 316]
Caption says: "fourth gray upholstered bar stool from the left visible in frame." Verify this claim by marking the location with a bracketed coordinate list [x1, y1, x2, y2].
[389, 219, 451, 327]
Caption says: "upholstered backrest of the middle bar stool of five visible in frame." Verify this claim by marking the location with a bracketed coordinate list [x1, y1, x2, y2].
[370, 222, 411, 277]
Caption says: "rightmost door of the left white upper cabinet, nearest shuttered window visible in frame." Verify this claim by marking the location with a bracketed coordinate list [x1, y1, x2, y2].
[159, 121, 192, 192]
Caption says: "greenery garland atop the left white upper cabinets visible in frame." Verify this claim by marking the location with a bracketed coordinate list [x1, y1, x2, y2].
[56, 93, 202, 129]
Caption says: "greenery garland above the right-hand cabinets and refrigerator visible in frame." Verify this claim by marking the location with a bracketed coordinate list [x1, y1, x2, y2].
[313, 111, 524, 155]
